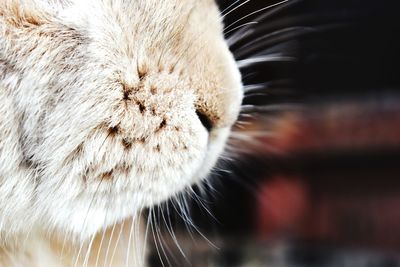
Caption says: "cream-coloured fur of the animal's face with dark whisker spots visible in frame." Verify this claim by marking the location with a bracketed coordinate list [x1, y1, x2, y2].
[0, 0, 242, 266]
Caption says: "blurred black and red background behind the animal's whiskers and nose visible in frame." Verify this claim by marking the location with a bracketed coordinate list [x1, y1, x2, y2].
[149, 0, 400, 267]
